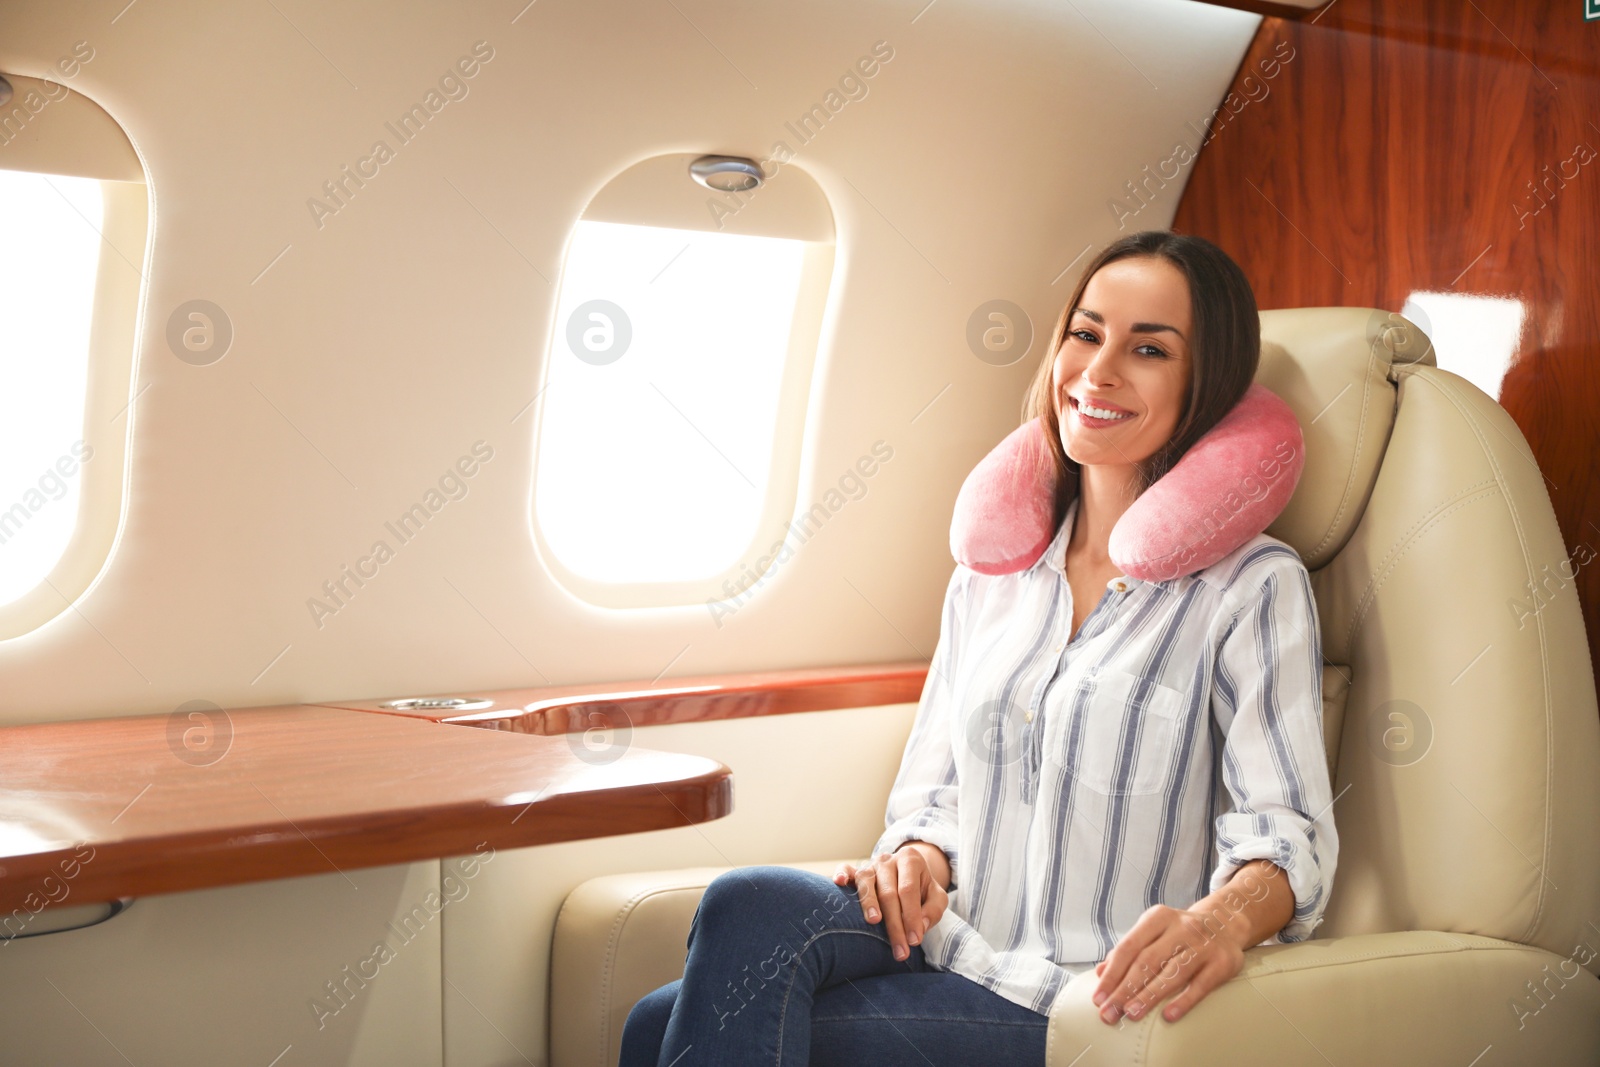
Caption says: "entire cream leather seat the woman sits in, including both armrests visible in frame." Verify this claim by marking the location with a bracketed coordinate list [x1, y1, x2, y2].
[550, 307, 1600, 1067]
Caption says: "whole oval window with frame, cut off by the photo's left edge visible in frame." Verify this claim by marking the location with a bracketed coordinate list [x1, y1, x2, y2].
[0, 73, 144, 641]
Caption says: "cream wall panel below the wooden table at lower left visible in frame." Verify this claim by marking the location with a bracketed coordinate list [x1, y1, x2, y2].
[0, 857, 444, 1067]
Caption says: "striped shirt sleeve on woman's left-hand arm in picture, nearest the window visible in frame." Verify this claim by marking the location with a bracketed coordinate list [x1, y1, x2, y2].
[872, 566, 971, 889]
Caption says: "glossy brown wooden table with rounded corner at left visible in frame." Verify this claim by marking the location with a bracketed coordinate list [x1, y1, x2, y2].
[0, 707, 733, 915]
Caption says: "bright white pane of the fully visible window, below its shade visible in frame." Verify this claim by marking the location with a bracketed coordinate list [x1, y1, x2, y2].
[534, 219, 806, 582]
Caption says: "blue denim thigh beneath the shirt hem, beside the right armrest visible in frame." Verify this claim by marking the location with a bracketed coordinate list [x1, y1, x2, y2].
[810, 971, 1050, 1067]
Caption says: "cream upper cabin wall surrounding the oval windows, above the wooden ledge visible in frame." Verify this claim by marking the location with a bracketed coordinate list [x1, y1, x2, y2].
[0, 0, 1259, 721]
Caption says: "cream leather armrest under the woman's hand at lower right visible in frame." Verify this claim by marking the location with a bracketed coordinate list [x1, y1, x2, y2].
[1046, 931, 1600, 1067]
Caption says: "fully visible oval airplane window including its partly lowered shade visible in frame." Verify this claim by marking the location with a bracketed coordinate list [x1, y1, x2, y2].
[533, 154, 834, 606]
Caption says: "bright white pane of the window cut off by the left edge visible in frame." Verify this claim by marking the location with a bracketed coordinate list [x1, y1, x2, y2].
[0, 170, 102, 605]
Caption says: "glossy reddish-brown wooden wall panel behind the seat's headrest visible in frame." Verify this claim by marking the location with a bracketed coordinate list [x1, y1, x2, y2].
[1173, 0, 1600, 694]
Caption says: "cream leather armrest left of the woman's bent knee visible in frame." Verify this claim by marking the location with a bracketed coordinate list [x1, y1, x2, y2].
[550, 856, 861, 1067]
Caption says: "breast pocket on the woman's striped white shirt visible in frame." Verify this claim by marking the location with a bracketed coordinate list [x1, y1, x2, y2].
[1043, 667, 1189, 797]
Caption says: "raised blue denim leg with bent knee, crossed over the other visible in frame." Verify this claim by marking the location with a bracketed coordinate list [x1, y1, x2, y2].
[649, 867, 928, 1067]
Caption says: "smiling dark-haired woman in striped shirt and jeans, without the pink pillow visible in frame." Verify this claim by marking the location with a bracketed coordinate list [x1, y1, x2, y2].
[621, 232, 1338, 1067]
